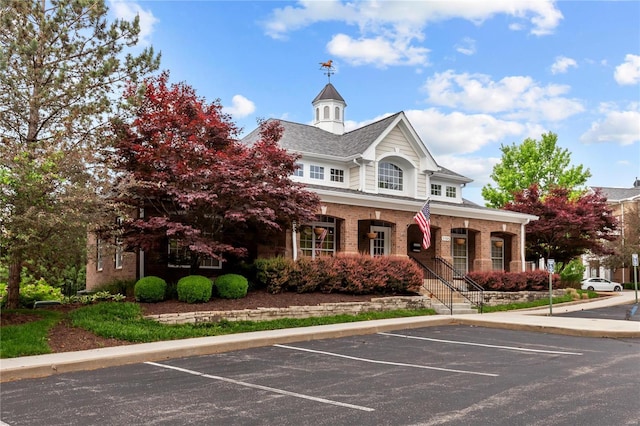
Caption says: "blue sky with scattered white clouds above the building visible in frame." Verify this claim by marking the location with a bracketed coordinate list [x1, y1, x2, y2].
[108, 0, 640, 204]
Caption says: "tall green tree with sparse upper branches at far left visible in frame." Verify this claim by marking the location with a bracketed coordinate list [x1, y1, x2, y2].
[0, 0, 159, 308]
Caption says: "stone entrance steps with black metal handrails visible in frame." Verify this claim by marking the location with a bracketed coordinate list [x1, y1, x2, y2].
[413, 257, 484, 314]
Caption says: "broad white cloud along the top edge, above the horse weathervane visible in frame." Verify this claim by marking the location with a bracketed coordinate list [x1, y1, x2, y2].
[264, 0, 562, 67]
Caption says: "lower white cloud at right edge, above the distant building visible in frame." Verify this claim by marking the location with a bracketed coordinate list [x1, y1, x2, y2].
[580, 105, 640, 145]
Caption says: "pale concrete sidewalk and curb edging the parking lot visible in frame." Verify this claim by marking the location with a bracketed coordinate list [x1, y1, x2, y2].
[0, 291, 640, 382]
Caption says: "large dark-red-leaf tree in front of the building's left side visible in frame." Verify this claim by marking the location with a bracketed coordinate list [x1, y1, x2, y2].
[114, 72, 318, 269]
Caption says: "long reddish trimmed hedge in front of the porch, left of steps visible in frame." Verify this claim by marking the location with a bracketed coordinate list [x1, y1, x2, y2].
[256, 255, 422, 294]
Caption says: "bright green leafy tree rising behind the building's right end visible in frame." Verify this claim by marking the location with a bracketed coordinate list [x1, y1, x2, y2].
[482, 132, 591, 208]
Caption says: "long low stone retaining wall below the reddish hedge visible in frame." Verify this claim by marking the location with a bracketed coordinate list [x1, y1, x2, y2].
[145, 296, 431, 324]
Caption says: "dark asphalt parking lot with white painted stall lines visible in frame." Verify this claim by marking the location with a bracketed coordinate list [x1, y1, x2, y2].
[1, 326, 640, 426]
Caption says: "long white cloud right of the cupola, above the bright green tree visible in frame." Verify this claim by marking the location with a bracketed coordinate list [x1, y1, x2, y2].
[424, 70, 584, 121]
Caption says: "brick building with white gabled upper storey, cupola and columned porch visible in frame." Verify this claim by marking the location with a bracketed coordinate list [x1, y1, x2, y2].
[87, 79, 537, 288]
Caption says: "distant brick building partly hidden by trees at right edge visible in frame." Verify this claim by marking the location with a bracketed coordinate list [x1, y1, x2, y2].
[582, 179, 640, 283]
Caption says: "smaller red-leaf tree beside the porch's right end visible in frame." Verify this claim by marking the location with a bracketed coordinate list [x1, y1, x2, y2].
[504, 184, 618, 263]
